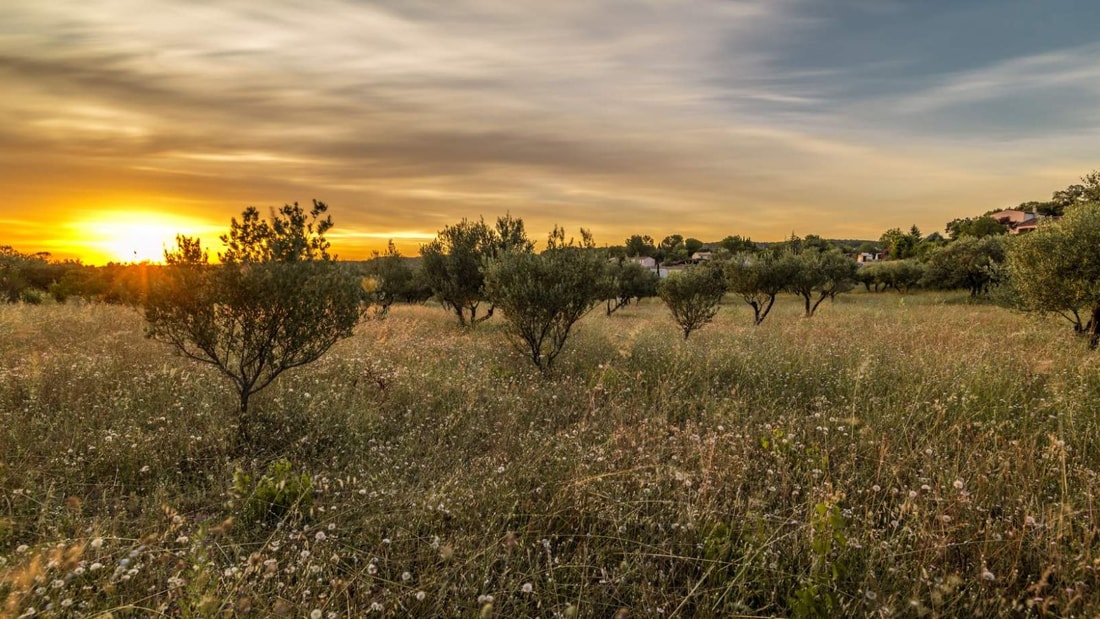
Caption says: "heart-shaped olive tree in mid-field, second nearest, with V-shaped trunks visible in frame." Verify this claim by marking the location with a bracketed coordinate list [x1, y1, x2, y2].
[485, 228, 606, 372]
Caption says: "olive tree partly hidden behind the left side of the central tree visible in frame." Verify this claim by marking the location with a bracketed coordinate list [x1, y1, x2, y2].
[420, 215, 535, 327]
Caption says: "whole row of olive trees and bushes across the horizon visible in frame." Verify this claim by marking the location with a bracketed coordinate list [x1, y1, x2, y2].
[0, 173, 1100, 445]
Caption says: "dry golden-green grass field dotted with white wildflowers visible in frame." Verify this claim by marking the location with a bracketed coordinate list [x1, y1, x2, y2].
[0, 294, 1100, 618]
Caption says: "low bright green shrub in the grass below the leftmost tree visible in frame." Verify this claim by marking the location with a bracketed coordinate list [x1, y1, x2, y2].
[233, 457, 314, 524]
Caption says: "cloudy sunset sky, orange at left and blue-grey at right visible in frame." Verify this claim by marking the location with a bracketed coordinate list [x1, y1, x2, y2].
[0, 0, 1100, 264]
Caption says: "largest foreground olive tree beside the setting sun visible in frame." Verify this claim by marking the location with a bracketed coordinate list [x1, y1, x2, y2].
[145, 201, 362, 447]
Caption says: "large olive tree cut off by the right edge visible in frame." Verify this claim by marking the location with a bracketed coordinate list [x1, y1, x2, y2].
[1007, 202, 1100, 349]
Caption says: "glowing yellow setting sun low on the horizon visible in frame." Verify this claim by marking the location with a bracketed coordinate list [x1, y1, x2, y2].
[74, 211, 217, 263]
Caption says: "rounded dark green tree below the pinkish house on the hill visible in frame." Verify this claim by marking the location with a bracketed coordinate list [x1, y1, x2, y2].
[921, 236, 1005, 297]
